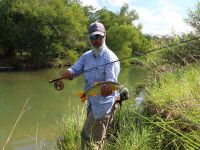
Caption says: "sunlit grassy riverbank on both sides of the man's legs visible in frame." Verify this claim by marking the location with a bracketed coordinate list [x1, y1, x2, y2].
[59, 64, 200, 150]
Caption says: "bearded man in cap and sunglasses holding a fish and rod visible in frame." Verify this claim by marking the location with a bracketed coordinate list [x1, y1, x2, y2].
[63, 22, 120, 149]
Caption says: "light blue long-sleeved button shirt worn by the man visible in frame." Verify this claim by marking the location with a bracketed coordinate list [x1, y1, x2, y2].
[69, 45, 120, 119]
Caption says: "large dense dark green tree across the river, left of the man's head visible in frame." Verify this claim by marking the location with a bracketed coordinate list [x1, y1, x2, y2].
[0, 0, 87, 67]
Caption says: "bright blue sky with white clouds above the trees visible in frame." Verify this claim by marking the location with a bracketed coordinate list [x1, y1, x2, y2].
[80, 0, 200, 35]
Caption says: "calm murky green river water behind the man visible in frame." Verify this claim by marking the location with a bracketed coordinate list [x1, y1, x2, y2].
[0, 67, 145, 150]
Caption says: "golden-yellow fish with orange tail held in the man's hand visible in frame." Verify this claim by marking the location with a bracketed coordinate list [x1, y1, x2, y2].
[79, 81, 122, 103]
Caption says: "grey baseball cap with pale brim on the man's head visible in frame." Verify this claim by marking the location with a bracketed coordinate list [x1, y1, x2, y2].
[88, 22, 106, 37]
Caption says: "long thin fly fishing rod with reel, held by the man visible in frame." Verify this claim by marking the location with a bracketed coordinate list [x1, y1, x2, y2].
[49, 37, 200, 88]
